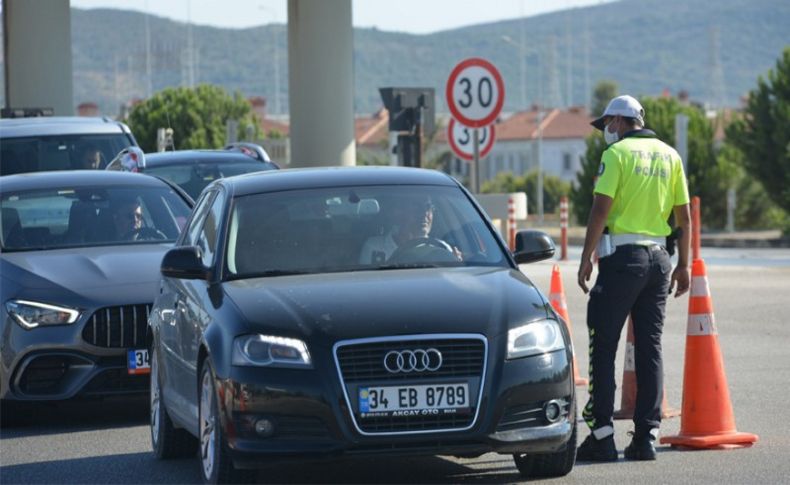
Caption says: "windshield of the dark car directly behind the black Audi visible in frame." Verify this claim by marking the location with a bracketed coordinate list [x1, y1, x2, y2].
[145, 160, 275, 200]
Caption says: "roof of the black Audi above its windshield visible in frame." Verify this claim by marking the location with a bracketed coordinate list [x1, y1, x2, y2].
[220, 167, 458, 196]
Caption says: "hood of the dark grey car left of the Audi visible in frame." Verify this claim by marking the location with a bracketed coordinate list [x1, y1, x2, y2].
[2, 244, 171, 304]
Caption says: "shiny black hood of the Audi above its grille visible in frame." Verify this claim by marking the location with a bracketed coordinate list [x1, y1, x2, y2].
[223, 267, 548, 343]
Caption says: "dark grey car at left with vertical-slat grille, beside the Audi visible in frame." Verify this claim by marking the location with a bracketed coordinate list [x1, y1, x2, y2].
[0, 170, 191, 412]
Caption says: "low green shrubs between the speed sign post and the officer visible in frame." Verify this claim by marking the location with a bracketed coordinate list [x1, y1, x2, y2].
[480, 170, 571, 214]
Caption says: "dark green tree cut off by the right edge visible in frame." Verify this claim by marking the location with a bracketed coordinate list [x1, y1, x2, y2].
[726, 47, 790, 212]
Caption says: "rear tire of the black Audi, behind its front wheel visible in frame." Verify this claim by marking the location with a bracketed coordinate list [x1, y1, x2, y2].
[151, 349, 197, 460]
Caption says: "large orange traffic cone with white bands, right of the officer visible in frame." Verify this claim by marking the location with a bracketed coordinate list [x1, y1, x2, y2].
[661, 259, 758, 448]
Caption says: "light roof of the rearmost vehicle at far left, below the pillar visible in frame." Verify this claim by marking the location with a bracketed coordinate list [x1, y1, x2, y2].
[0, 116, 128, 138]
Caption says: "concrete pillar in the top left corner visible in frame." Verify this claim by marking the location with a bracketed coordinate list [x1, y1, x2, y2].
[3, 0, 74, 116]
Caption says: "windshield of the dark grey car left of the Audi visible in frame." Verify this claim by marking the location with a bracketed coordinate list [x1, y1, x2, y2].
[0, 182, 190, 251]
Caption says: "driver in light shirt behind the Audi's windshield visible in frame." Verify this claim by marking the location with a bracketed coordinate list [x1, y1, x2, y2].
[359, 197, 462, 264]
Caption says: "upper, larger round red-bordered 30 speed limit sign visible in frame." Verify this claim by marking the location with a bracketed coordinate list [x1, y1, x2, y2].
[446, 57, 505, 128]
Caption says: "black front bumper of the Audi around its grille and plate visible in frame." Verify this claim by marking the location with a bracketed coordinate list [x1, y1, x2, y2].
[216, 342, 575, 468]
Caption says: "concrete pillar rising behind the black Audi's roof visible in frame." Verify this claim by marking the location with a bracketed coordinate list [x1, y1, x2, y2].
[288, 0, 356, 167]
